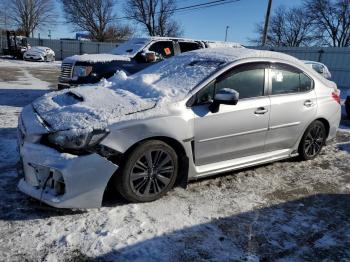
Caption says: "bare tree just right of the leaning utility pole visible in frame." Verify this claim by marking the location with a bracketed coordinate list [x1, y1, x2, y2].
[251, 6, 316, 46]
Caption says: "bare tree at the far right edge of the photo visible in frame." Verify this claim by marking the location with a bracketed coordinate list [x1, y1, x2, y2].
[304, 0, 350, 47]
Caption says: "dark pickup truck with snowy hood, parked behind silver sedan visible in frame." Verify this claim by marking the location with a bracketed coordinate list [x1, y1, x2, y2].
[58, 37, 243, 89]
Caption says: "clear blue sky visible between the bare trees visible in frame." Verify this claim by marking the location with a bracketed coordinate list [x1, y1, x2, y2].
[43, 0, 302, 44]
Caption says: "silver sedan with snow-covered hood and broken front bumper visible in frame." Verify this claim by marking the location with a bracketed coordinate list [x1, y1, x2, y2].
[19, 48, 341, 208]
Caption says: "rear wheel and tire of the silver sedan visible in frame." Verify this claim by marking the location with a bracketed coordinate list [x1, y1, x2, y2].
[298, 120, 327, 160]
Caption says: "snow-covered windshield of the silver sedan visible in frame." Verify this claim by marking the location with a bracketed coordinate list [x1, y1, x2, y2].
[110, 52, 225, 101]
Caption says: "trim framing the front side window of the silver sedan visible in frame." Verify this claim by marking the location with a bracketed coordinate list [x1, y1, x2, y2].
[190, 61, 271, 107]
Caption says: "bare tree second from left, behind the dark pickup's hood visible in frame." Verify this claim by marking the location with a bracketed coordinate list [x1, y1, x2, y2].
[61, 0, 131, 42]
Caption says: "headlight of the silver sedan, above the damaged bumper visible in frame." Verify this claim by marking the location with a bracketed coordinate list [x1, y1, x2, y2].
[47, 130, 109, 150]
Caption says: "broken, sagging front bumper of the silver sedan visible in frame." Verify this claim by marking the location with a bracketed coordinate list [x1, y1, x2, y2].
[18, 142, 118, 208]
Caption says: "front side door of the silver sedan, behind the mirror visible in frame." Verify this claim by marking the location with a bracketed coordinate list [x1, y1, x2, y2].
[192, 63, 270, 165]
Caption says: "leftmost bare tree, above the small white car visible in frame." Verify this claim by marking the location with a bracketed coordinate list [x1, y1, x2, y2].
[6, 0, 54, 37]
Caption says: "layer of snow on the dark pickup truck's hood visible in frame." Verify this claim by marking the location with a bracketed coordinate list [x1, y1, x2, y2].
[63, 54, 131, 63]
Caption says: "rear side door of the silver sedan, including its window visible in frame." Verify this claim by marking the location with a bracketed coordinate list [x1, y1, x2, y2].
[265, 64, 317, 151]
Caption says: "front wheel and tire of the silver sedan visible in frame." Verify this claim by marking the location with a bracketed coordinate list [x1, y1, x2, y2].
[115, 140, 179, 202]
